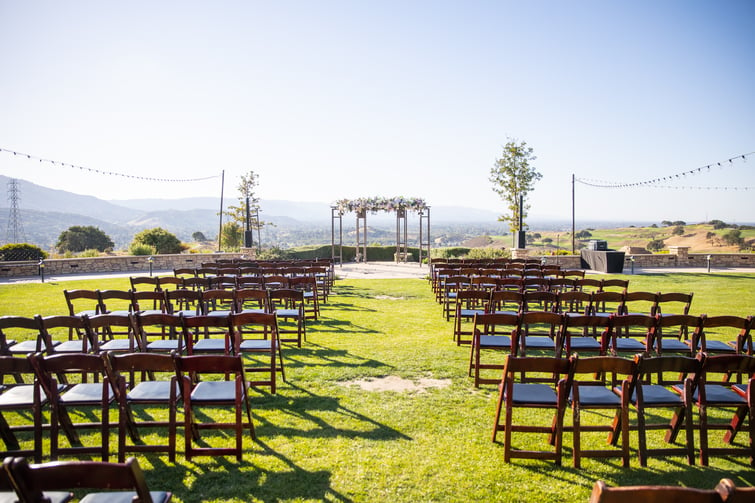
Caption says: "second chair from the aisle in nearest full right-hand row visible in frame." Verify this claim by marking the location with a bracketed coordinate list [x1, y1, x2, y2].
[569, 355, 635, 468]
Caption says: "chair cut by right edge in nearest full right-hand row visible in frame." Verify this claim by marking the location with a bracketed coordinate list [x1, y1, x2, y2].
[694, 354, 755, 466]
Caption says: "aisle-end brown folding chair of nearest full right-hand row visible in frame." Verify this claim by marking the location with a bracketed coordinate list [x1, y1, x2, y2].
[493, 355, 569, 465]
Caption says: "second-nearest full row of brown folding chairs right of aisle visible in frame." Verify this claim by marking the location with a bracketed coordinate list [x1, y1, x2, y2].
[470, 311, 755, 387]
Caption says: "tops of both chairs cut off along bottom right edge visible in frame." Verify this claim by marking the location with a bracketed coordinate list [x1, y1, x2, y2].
[589, 478, 755, 503]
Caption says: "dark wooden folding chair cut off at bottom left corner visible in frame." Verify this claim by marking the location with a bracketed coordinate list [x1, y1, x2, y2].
[10, 458, 173, 503]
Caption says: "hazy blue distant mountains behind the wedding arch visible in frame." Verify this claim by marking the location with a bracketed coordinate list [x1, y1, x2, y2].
[0, 175, 516, 250]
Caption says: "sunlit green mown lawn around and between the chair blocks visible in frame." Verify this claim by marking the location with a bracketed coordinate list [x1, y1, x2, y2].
[0, 274, 755, 502]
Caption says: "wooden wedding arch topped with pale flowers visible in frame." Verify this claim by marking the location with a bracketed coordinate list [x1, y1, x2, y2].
[330, 197, 430, 266]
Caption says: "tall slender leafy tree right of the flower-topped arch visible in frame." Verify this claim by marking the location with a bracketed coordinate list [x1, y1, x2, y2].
[490, 140, 543, 236]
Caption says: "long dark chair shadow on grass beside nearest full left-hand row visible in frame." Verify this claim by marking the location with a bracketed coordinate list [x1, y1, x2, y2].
[252, 386, 411, 441]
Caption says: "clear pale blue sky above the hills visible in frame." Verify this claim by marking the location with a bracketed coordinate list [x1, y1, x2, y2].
[0, 0, 755, 222]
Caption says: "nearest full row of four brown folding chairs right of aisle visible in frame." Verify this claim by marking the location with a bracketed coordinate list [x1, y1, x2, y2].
[493, 353, 755, 467]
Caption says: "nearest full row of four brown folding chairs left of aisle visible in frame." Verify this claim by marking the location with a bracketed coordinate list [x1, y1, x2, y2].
[0, 352, 255, 462]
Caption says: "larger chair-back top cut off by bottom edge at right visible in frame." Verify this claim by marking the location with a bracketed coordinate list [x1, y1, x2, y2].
[589, 480, 725, 503]
